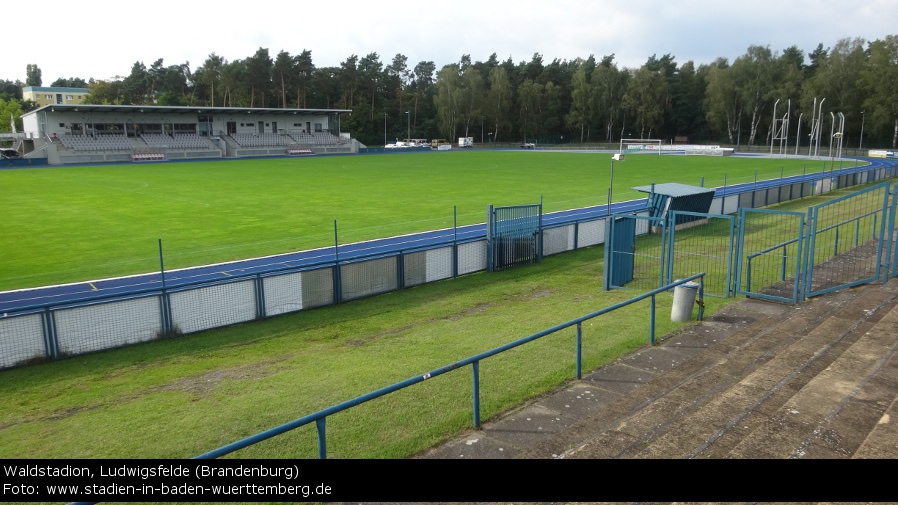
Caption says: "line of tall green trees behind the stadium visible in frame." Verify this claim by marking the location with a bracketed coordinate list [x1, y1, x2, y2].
[0, 35, 898, 148]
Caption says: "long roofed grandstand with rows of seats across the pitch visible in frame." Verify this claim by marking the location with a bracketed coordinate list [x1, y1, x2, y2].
[19, 104, 359, 165]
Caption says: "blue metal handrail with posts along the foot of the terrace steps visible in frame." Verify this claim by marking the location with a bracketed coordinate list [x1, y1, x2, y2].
[193, 272, 705, 459]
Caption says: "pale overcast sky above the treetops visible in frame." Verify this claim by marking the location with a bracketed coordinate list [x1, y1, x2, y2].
[7, 0, 898, 86]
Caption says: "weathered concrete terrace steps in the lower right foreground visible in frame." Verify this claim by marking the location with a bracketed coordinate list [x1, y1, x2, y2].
[418, 279, 898, 459]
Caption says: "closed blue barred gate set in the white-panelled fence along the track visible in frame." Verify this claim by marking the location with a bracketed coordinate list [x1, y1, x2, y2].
[486, 204, 543, 272]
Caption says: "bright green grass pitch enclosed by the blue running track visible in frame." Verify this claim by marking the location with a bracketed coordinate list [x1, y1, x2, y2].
[0, 151, 826, 290]
